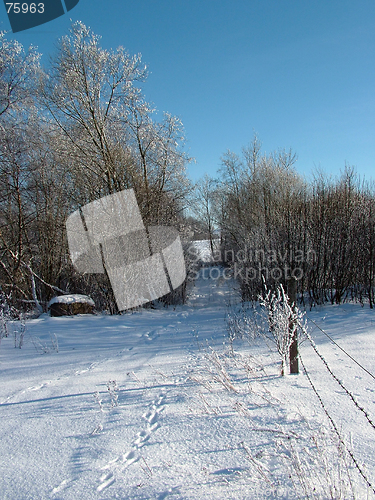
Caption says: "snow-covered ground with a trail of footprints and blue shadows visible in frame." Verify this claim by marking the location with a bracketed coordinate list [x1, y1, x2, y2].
[0, 260, 375, 500]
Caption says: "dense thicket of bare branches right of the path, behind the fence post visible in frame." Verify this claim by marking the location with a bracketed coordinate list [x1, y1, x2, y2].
[199, 137, 375, 307]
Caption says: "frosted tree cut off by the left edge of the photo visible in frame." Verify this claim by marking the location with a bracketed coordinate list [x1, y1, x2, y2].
[0, 33, 40, 308]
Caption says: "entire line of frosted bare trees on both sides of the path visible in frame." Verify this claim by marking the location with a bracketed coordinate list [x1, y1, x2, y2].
[0, 22, 375, 312]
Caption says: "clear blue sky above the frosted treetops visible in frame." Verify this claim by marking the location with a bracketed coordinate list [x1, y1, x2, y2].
[0, 0, 375, 184]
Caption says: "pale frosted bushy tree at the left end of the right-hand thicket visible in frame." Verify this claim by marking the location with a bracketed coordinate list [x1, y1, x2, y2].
[219, 137, 307, 300]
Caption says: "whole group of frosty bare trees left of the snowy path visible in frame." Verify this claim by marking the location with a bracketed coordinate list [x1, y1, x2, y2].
[0, 22, 189, 310]
